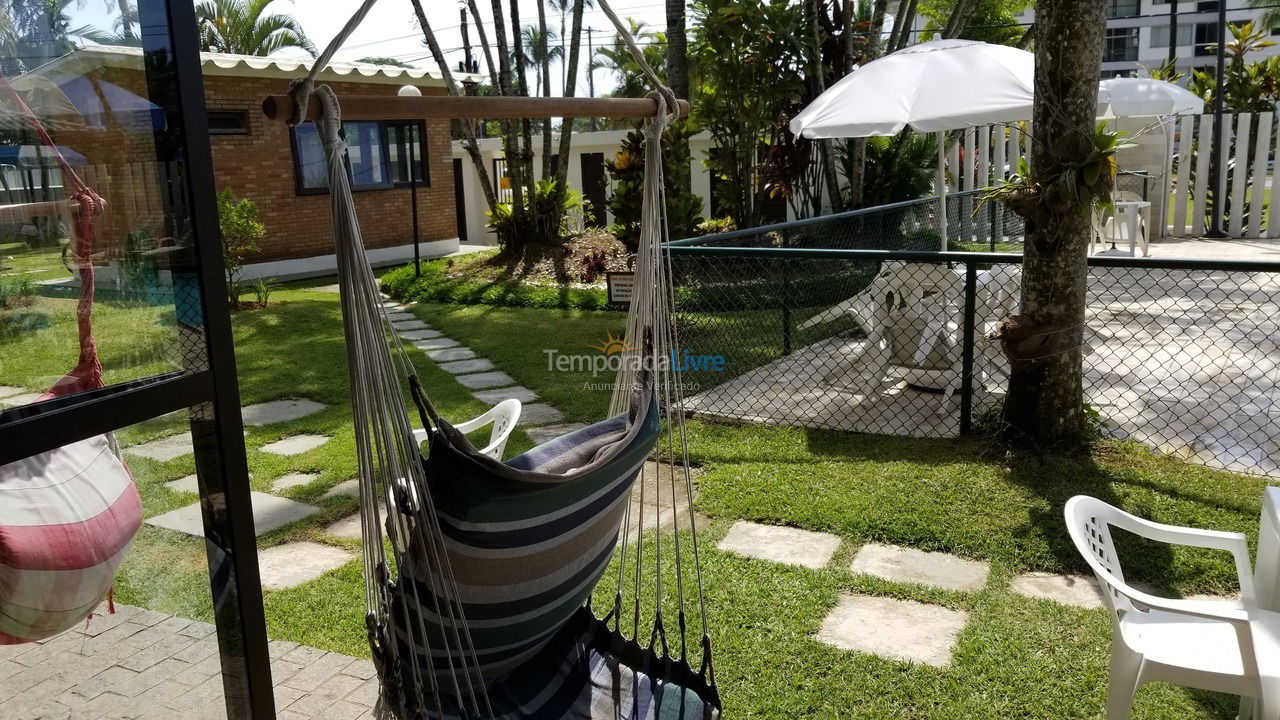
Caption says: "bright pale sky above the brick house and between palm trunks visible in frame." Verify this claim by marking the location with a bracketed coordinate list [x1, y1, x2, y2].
[68, 0, 666, 94]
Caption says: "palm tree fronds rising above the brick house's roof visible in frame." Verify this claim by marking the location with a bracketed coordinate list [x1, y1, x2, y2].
[196, 0, 316, 58]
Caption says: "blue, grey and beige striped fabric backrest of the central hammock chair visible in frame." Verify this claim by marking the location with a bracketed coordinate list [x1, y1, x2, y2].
[389, 398, 659, 683]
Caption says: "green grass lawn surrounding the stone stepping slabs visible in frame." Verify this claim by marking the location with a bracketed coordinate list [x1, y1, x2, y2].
[0, 274, 1265, 720]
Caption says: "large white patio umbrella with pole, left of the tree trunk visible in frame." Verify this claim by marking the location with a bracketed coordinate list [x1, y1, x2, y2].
[791, 40, 1036, 250]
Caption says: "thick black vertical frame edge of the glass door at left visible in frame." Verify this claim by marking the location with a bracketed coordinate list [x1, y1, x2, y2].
[156, 0, 275, 720]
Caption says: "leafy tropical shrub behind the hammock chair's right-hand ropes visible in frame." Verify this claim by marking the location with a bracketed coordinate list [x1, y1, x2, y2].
[604, 123, 703, 252]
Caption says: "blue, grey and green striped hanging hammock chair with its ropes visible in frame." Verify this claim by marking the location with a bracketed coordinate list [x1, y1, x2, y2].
[292, 0, 721, 720]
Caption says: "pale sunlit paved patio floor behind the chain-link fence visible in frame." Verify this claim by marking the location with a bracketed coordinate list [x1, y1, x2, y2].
[686, 254, 1280, 477]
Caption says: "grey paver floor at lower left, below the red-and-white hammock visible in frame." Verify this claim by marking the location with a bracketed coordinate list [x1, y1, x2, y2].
[0, 605, 378, 720]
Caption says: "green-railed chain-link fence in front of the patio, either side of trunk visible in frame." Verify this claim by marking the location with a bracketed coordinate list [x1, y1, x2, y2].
[671, 197, 1280, 477]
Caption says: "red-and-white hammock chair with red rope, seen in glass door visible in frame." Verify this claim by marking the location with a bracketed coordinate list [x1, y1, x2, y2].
[0, 76, 142, 646]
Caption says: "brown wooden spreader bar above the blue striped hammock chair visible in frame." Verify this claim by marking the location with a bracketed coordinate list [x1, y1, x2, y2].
[262, 95, 689, 120]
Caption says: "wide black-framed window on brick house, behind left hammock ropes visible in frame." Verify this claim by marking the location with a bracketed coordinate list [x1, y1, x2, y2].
[293, 120, 408, 195]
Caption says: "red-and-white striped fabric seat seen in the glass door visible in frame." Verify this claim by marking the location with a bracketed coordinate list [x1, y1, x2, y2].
[0, 427, 142, 644]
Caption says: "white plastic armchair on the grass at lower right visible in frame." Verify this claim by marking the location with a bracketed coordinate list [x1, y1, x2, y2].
[1065, 496, 1266, 720]
